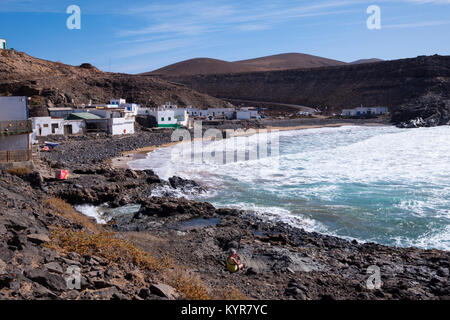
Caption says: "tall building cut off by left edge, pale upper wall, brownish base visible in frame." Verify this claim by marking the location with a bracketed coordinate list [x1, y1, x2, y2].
[0, 97, 32, 163]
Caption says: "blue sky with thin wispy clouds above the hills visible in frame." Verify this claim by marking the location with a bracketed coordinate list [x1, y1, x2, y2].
[0, 0, 450, 73]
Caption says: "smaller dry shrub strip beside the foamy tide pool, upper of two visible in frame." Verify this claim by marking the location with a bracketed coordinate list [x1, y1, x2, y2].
[44, 198, 101, 233]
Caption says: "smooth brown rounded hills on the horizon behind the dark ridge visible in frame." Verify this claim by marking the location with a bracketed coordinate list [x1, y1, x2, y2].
[146, 53, 346, 77]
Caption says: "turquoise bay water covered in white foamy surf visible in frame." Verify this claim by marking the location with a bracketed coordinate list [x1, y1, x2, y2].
[131, 126, 450, 250]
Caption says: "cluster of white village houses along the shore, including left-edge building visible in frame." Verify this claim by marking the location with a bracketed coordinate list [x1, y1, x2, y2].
[0, 97, 261, 162]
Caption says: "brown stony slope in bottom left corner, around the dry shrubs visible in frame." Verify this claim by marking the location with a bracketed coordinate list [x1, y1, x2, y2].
[0, 171, 172, 300]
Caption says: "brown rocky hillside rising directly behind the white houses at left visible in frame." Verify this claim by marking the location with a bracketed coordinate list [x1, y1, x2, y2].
[0, 50, 232, 115]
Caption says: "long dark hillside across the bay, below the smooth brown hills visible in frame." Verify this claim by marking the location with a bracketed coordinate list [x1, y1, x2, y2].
[167, 55, 450, 121]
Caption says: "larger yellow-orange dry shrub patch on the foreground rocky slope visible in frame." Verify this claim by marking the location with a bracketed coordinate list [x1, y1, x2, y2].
[51, 228, 168, 271]
